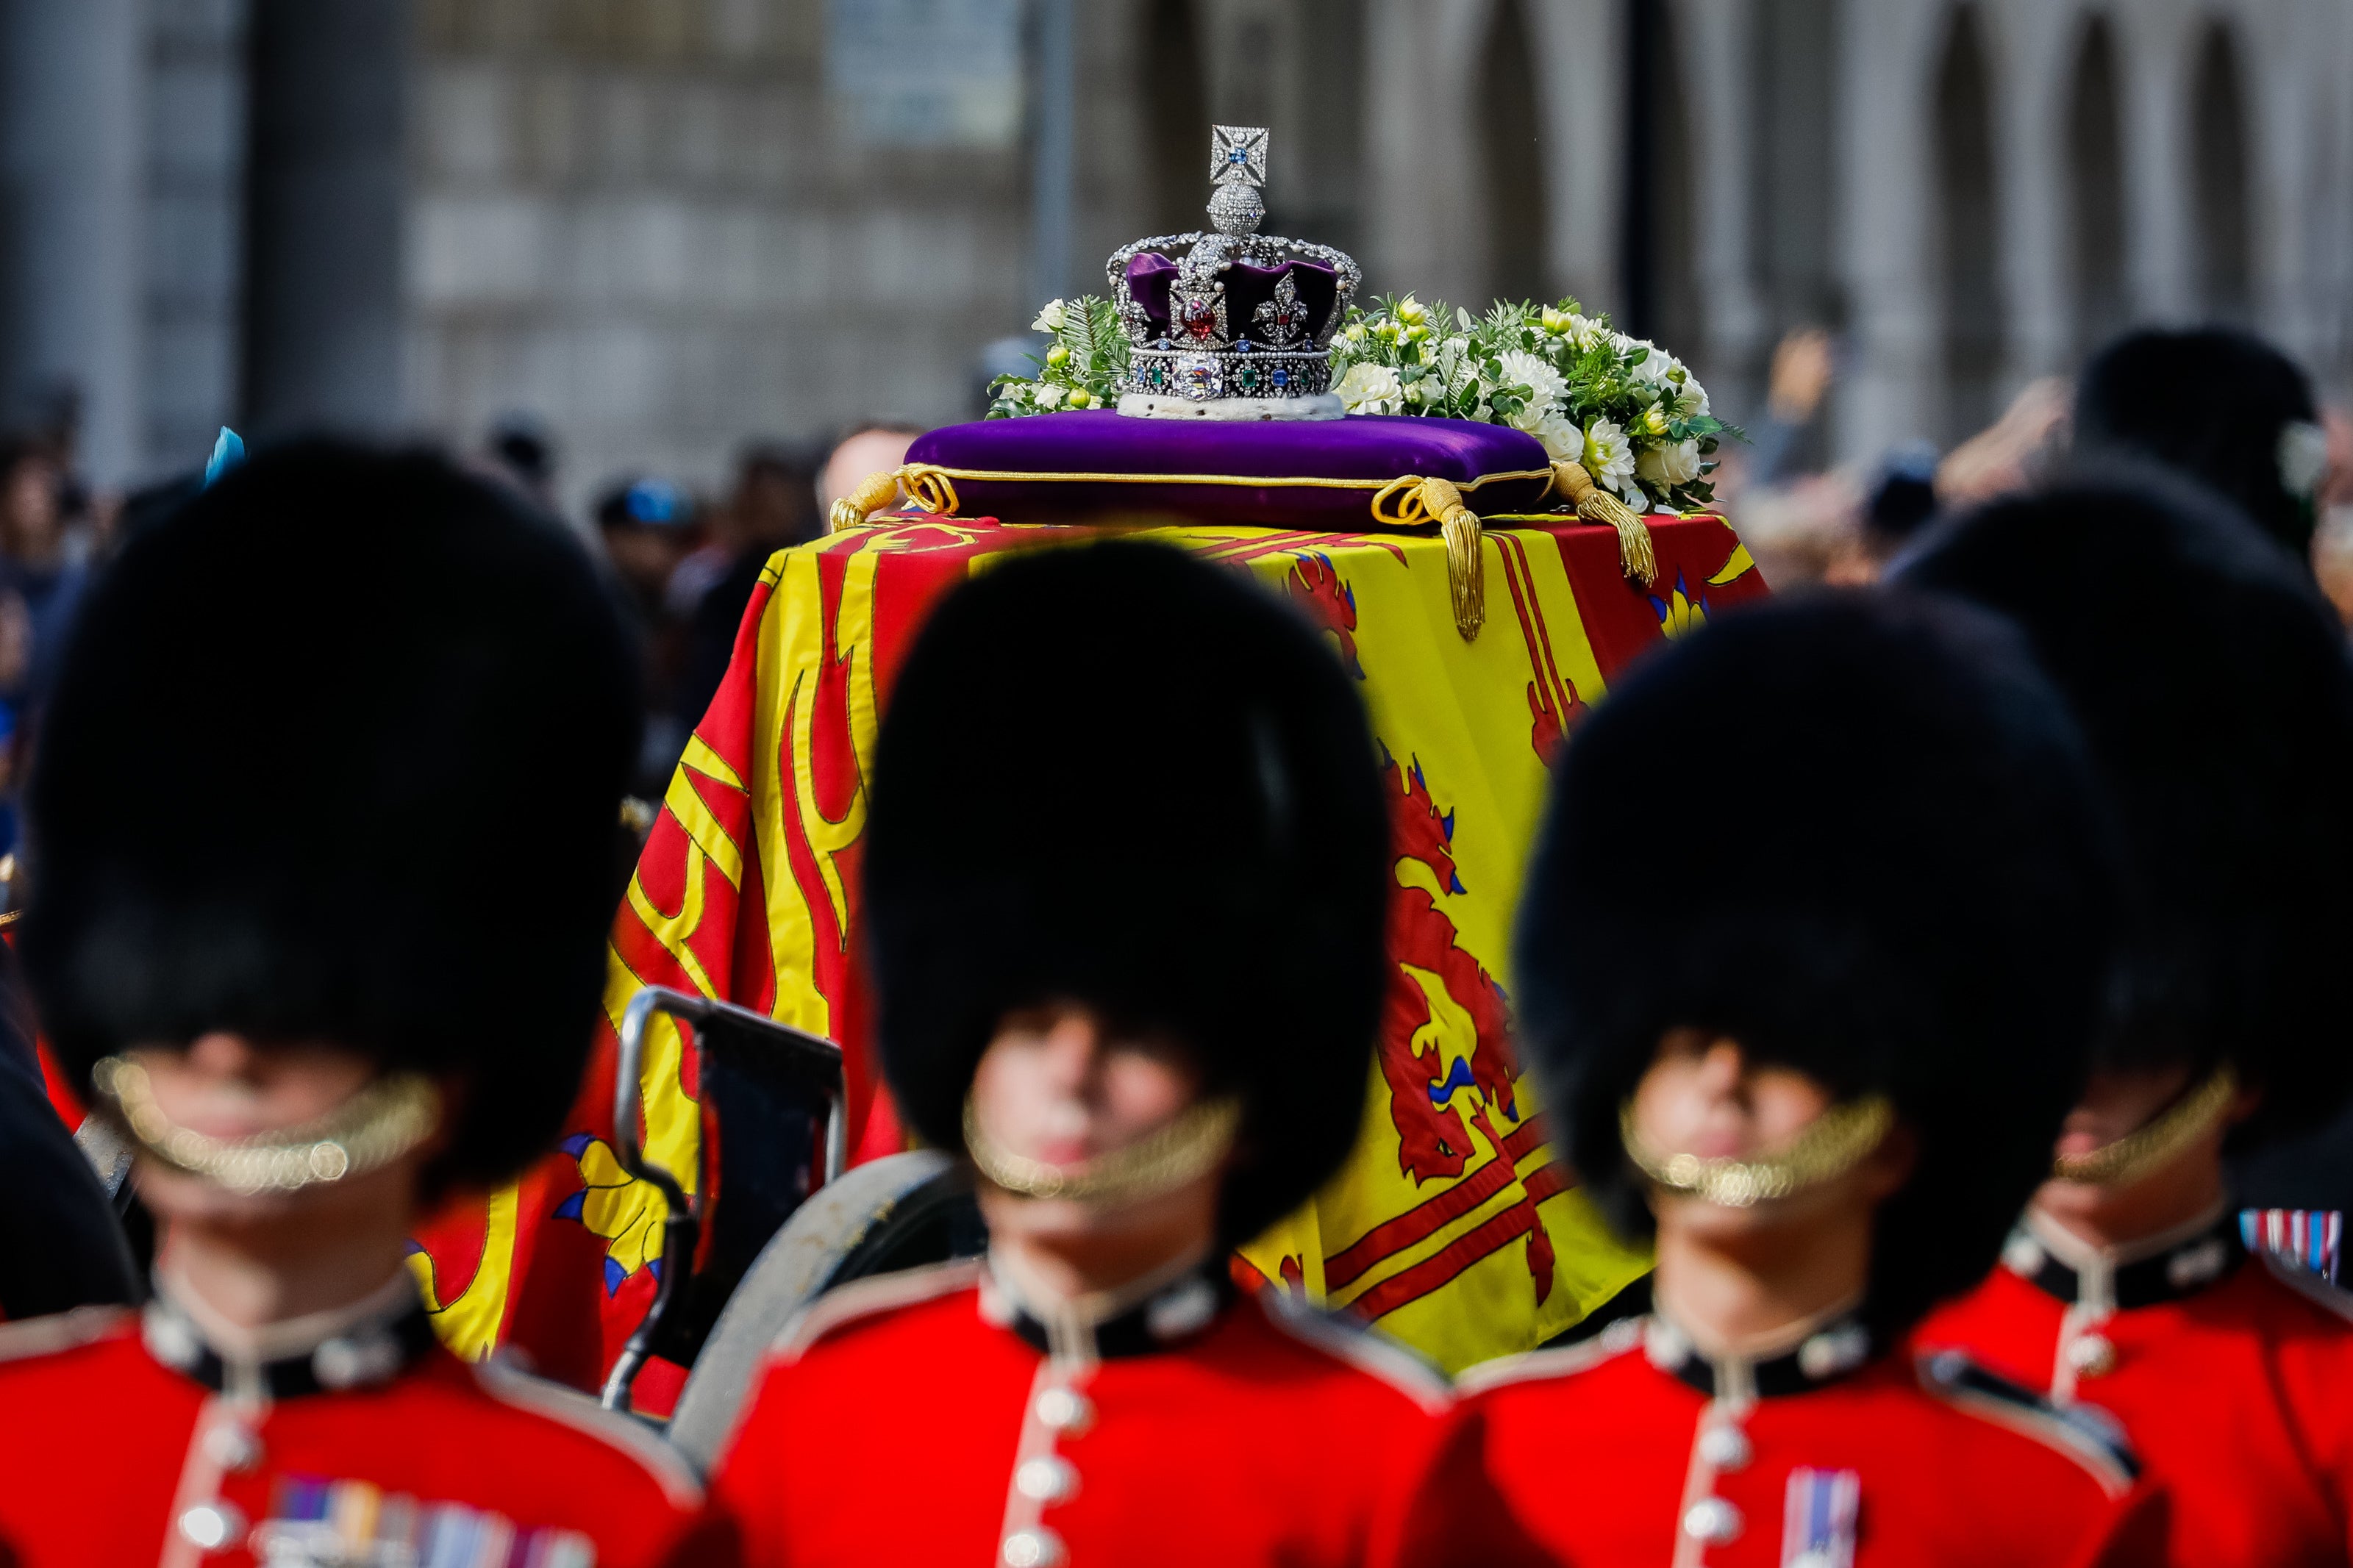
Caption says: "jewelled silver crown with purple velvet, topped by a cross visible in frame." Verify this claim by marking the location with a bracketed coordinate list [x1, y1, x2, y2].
[1104, 124, 1363, 418]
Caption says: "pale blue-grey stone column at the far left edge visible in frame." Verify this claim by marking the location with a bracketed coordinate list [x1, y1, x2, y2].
[0, 0, 143, 484]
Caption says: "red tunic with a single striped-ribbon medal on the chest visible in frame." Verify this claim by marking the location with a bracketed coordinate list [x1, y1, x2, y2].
[1419, 1317, 2157, 1568]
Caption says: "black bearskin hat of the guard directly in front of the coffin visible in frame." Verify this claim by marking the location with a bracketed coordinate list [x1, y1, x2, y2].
[866, 543, 1388, 1244]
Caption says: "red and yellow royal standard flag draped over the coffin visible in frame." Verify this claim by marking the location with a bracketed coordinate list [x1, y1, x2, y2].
[404, 503, 1763, 1385]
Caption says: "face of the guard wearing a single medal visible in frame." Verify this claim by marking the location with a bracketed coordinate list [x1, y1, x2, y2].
[1633, 1030, 1908, 1239]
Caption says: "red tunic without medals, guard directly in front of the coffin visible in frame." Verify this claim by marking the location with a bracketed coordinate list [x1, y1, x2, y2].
[713, 1262, 1496, 1568]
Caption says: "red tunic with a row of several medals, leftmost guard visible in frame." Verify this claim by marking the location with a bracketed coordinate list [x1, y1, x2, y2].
[0, 1274, 725, 1568]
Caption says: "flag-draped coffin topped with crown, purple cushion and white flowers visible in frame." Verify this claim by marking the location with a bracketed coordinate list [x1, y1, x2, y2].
[412, 127, 1765, 1382]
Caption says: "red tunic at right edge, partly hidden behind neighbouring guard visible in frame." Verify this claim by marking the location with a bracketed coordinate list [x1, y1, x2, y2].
[1920, 1213, 2353, 1568]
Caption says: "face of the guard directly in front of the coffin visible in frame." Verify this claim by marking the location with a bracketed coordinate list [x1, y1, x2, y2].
[972, 1001, 1216, 1230]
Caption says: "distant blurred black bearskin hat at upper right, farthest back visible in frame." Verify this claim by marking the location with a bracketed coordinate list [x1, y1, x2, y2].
[2075, 327, 2320, 562]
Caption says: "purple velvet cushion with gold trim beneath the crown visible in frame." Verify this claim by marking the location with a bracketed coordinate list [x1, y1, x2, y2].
[906, 409, 1551, 529]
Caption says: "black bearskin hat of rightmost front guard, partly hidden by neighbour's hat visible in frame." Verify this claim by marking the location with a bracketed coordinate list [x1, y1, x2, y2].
[1904, 473, 2353, 1150]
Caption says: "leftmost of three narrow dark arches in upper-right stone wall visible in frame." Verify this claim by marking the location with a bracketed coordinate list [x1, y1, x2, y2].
[1934, 4, 2004, 440]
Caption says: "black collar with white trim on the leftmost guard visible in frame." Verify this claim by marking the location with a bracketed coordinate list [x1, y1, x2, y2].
[141, 1270, 435, 1401]
